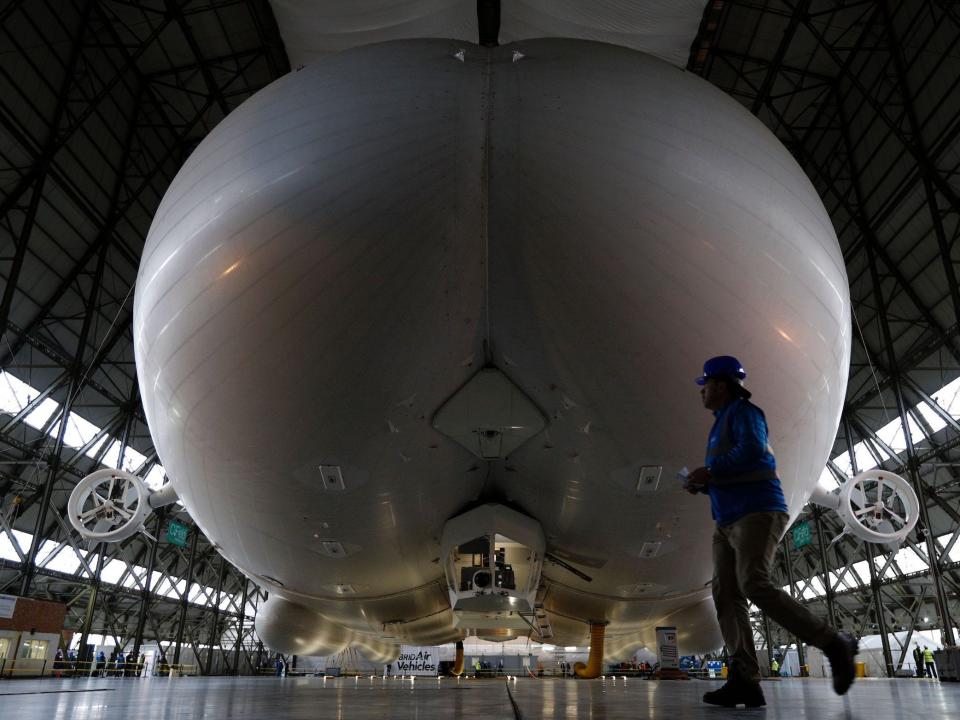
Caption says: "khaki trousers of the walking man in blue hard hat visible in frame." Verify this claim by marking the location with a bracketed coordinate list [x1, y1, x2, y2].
[713, 512, 837, 681]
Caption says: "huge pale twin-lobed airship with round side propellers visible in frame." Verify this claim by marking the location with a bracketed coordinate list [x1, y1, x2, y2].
[63, 39, 917, 676]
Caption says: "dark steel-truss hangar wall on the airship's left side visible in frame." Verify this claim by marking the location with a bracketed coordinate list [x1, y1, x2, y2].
[0, 0, 289, 674]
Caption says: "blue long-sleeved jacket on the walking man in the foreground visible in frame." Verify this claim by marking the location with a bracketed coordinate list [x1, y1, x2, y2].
[705, 398, 787, 526]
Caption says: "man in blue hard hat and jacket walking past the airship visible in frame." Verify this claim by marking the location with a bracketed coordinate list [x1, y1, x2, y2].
[684, 355, 857, 707]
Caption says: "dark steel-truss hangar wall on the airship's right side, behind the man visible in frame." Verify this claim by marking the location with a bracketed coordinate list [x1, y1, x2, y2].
[688, 0, 960, 675]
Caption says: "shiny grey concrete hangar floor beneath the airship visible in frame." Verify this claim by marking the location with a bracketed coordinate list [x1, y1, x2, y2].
[0, 677, 960, 720]
